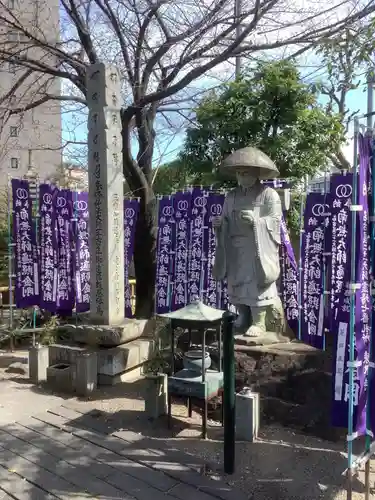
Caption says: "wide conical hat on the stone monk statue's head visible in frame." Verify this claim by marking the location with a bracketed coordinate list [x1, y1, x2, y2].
[220, 146, 279, 179]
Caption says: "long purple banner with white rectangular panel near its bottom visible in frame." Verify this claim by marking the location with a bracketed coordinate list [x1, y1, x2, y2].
[330, 174, 358, 428]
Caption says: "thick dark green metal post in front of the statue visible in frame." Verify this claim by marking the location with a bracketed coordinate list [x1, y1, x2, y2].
[223, 312, 236, 474]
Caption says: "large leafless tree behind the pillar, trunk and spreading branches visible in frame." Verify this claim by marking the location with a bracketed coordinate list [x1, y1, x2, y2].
[0, 0, 375, 317]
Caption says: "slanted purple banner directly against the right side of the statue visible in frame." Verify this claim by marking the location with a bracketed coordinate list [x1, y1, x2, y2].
[280, 217, 299, 337]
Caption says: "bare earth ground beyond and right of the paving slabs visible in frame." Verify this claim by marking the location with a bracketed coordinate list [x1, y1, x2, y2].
[0, 352, 375, 500]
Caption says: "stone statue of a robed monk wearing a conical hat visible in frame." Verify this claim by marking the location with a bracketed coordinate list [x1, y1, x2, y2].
[213, 147, 282, 337]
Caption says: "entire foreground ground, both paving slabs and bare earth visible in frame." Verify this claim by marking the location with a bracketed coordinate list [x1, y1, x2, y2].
[0, 353, 375, 500]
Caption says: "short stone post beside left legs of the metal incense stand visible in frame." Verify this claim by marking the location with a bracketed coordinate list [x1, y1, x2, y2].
[145, 373, 168, 420]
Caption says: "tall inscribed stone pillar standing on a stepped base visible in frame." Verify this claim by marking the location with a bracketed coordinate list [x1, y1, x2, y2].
[87, 63, 124, 326]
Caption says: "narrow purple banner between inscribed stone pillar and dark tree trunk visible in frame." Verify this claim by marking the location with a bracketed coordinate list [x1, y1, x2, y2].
[124, 199, 139, 318]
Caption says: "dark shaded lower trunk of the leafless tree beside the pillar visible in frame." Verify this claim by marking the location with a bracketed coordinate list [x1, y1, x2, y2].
[134, 188, 157, 319]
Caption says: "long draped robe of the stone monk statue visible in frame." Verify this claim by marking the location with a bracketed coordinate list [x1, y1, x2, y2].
[213, 182, 282, 307]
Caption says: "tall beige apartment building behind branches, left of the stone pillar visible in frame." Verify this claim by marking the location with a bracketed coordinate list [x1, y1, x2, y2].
[0, 0, 62, 185]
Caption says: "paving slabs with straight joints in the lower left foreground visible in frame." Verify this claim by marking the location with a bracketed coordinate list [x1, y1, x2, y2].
[0, 405, 246, 500]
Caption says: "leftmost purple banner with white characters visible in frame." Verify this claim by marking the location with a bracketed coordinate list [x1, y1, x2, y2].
[12, 179, 39, 309]
